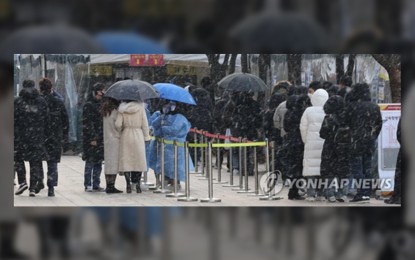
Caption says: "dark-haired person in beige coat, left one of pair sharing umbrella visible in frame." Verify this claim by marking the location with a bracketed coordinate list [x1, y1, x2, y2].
[101, 97, 122, 194]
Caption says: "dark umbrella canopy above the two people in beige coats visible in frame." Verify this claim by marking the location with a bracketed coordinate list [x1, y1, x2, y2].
[105, 79, 159, 101]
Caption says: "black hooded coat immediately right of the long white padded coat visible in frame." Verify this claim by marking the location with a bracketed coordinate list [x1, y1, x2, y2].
[320, 96, 351, 178]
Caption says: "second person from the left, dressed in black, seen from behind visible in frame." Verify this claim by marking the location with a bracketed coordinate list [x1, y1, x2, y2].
[38, 78, 69, 197]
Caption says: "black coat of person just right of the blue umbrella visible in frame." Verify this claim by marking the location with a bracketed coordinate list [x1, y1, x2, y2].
[187, 88, 213, 133]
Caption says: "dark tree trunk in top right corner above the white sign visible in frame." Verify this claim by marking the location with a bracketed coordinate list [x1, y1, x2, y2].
[372, 54, 401, 103]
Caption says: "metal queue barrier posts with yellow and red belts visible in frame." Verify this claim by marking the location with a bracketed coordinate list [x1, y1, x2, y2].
[154, 130, 281, 203]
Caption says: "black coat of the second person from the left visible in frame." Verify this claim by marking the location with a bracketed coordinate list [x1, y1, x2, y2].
[43, 94, 69, 162]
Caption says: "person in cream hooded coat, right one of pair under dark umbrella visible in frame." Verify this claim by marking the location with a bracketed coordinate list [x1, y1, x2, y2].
[115, 101, 150, 193]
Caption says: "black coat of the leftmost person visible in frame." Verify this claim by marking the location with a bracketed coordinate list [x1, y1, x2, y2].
[14, 88, 49, 161]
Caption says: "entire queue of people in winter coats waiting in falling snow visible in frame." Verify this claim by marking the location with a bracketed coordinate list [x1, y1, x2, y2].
[15, 75, 395, 202]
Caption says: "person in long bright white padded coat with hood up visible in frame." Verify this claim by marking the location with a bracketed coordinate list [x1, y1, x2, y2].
[300, 89, 329, 201]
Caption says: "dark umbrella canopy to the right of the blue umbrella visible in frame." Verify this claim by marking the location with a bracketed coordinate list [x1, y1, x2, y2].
[218, 73, 267, 92]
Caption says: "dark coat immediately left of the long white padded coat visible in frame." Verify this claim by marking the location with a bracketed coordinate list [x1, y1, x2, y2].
[280, 95, 310, 178]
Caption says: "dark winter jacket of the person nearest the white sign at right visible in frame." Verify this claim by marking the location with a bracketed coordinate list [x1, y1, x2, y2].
[345, 84, 382, 155]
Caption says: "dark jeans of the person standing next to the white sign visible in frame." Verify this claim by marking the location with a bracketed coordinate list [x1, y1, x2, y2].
[351, 152, 372, 196]
